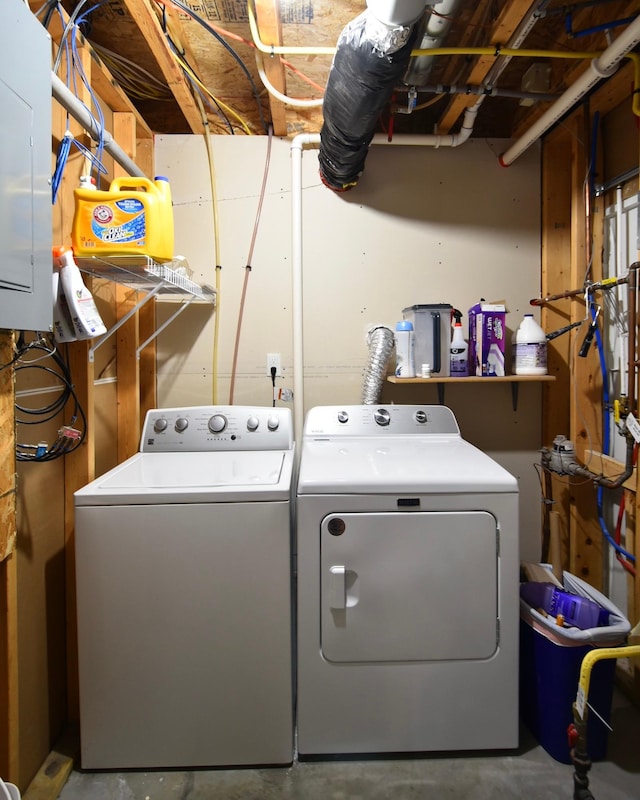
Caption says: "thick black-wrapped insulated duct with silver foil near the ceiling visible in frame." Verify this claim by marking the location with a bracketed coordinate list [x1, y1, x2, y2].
[318, 9, 422, 192]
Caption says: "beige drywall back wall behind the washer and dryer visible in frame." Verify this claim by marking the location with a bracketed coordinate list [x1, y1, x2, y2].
[156, 135, 541, 558]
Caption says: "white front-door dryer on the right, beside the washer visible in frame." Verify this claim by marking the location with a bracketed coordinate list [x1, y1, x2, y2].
[296, 405, 519, 757]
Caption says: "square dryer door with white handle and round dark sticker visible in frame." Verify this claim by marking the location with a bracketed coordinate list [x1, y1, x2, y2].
[320, 511, 499, 662]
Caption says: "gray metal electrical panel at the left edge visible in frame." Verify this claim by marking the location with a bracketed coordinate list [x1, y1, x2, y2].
[0, 0, 52, 331]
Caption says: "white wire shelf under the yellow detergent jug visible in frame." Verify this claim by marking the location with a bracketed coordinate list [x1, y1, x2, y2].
[76, 256, 216, 303]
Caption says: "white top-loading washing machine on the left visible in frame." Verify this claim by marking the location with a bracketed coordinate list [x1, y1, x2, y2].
[75, 406, 294, 769]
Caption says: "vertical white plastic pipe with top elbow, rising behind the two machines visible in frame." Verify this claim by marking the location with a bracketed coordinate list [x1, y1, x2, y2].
[291, 133, 320, 444]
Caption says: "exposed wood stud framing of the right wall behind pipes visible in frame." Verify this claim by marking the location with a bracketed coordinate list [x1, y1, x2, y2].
[541, 73, 640, 702]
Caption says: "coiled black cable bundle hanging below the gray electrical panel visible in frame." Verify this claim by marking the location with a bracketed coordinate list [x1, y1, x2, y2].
[0, 332, 87, 462]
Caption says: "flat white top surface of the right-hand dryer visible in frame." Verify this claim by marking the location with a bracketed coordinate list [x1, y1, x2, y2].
[298, 436, 518, 495]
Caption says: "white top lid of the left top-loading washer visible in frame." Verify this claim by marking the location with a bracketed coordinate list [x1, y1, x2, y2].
[75, 450, 293, 505]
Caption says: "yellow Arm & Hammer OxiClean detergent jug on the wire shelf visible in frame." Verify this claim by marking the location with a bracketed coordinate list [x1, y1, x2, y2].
[71, 176, 173, 262]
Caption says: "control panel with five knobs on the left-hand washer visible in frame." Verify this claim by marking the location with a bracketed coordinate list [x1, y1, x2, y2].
[140, 406, 293, 453]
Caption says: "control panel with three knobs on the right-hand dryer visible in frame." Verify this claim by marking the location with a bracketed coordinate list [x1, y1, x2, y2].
[304, 405, 460, 439]
